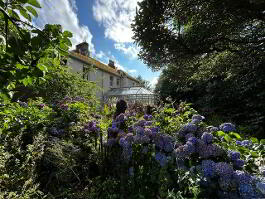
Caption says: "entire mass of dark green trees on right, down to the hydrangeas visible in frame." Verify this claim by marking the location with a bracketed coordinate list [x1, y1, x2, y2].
[132, 0, 265, 136]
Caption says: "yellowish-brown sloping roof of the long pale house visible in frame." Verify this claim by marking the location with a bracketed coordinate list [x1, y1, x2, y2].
[69, 52, 140, 83]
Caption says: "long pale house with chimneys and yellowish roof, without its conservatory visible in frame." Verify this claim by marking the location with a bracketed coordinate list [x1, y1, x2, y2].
[67, 42, 140, 98]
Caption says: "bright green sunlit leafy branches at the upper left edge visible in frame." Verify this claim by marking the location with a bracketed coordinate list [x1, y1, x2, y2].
[0, 0, 72, 98]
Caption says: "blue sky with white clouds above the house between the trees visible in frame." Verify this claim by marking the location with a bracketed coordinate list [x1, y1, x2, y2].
[34, 0, 160, 86]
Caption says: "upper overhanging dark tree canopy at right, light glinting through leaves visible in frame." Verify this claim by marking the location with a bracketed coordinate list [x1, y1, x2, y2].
[132, 0, 265, 70]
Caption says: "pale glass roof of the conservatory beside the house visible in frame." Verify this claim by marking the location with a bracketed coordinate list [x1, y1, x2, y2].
[105, 86, 154, 96]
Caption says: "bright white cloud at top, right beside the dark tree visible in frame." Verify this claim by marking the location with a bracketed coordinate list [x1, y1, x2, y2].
[93, 0, 140, 43]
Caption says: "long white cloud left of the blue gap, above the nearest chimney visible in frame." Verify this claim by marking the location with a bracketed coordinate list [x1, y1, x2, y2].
[34, 0, 95, 54]
